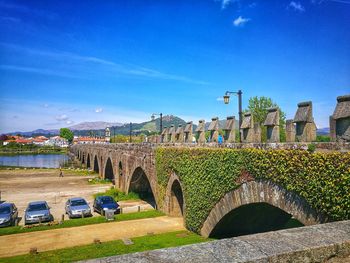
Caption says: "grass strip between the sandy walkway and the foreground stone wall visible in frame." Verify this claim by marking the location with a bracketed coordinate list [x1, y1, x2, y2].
[0, 231, 210, 263]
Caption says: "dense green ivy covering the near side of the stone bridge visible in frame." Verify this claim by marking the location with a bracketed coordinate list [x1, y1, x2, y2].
[156, 148, 350, 232]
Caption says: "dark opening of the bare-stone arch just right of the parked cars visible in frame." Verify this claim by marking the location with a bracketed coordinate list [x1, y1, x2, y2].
[127, 166, 156, 207]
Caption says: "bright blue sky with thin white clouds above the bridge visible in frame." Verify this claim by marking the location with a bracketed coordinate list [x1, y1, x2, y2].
[0, 0, 350, 133]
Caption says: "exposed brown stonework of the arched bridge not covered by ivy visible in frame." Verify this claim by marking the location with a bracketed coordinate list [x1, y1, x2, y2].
[71, 144, 342, 239]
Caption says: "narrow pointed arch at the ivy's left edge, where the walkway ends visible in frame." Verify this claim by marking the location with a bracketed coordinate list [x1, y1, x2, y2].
[165, 173, 185, 216]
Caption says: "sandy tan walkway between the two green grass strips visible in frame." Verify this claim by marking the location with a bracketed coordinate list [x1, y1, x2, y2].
[0, 216, 185, 257]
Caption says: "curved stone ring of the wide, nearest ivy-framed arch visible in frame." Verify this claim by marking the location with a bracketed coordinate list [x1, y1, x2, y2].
[201, 180, 326, 237]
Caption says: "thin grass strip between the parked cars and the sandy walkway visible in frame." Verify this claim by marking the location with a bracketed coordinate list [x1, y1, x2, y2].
[0, 210, 164, 236]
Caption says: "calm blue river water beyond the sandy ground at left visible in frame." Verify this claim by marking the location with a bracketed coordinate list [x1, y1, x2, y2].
[0, 154, 69, 168]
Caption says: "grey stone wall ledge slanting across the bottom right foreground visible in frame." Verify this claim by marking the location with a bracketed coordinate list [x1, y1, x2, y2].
[81, 221, 350, 263]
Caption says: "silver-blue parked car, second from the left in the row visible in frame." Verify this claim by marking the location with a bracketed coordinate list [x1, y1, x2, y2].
[24, 201, 53, 225]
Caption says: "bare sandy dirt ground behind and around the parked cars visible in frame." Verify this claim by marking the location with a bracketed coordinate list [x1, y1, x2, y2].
[0, 169, 153, 225]
